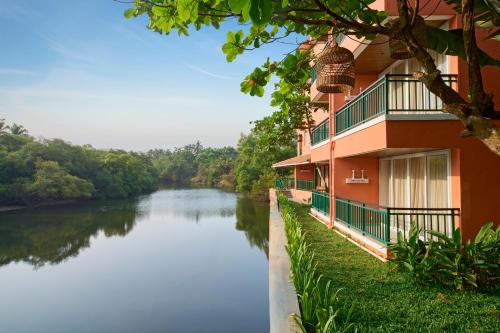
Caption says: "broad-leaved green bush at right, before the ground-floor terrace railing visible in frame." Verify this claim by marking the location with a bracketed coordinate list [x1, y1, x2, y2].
[389, 223, 500, 291]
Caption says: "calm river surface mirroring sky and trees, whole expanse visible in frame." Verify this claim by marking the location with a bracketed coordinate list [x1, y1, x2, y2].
[0, 189, 269, 333]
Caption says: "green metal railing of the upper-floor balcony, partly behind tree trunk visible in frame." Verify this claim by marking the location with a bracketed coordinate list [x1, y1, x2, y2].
[335, 74, 457, 135]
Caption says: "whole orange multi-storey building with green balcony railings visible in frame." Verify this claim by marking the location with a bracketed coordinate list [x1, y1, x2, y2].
[274, 0, 500, 257]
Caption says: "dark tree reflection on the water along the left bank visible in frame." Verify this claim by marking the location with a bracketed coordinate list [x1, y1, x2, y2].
[0, 201, 141, 268]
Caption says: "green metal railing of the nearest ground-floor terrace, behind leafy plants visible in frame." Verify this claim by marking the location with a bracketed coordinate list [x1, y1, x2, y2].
[335, 198, 460, 244]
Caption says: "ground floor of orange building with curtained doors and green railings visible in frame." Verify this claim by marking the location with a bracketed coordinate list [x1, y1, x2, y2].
[276, 139, 500, 258]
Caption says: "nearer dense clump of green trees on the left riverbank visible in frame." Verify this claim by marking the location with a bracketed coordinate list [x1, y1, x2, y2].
[0, 120, 157, 204]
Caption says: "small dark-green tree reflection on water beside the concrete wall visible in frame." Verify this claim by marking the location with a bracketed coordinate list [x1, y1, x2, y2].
[236, 197, 269, 257]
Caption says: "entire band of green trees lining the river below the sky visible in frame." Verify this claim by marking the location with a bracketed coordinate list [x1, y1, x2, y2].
[0, 119, 294, 205]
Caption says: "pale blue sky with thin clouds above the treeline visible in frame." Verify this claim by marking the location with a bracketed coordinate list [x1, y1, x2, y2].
[0, 0, 292, 150]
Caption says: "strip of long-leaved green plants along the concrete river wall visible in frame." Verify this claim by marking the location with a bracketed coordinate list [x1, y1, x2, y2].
[278, 194, 353, 333]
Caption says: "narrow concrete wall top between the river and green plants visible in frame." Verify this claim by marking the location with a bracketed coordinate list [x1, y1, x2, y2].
[269, 190, 300, 333]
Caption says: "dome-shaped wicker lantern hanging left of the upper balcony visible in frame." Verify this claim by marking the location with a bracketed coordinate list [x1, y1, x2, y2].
[316, 45, 356, 93]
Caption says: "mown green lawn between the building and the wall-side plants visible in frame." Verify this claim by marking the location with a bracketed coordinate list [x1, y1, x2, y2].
[294, 204, 500, 333]
